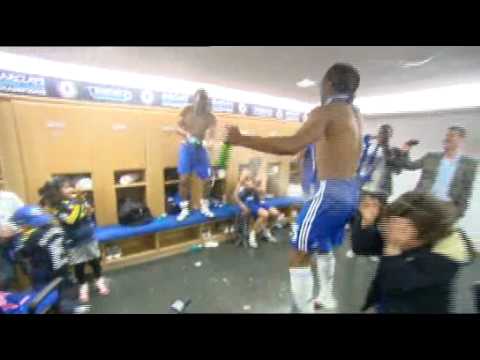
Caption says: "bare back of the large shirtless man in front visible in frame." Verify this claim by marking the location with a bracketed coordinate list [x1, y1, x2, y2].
[310, 103, 362, 180]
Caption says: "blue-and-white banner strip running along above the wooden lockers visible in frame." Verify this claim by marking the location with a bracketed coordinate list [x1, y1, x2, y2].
[0, 70, 304, 121]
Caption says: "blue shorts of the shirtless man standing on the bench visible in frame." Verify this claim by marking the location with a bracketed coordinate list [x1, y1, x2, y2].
[177, 142, 212, 180]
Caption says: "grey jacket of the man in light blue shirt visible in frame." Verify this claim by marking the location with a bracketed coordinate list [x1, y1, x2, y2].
[397, 152, 478, 218]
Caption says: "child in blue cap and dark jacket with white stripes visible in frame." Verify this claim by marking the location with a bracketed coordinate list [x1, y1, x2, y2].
[12, 206, 87, 313]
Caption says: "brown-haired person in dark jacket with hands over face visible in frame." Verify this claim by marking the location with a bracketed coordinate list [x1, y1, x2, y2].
[351, 192, 471, 313]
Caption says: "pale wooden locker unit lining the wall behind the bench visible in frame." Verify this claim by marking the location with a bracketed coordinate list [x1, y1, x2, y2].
[0, 97, 300, 267]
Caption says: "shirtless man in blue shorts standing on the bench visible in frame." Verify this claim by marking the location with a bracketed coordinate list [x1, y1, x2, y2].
[177, 89, 217, 221]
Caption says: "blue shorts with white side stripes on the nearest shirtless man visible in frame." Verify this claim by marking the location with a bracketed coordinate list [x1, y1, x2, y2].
[291, 178, 360, 252]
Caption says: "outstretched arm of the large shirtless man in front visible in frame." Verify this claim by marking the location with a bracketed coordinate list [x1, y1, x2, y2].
[226, 108, 329, 155]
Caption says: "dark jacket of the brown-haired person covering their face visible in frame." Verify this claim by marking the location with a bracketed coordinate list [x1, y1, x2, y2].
[352, 214, 472, 313]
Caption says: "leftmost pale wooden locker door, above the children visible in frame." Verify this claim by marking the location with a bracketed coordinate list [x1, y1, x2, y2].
[14, 101, 94, 201]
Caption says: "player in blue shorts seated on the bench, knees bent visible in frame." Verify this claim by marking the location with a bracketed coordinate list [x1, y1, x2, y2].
[234, 170, 280, 249]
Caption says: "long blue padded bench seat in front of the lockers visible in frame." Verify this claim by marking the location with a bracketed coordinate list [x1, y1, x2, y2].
[95, 196, 303, 243]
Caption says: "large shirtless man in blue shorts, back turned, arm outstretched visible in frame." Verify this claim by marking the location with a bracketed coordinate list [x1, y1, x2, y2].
[227, 64, 362, 312]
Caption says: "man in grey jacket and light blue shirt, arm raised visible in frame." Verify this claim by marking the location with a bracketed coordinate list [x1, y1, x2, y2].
[399, 126, 478, 219]
